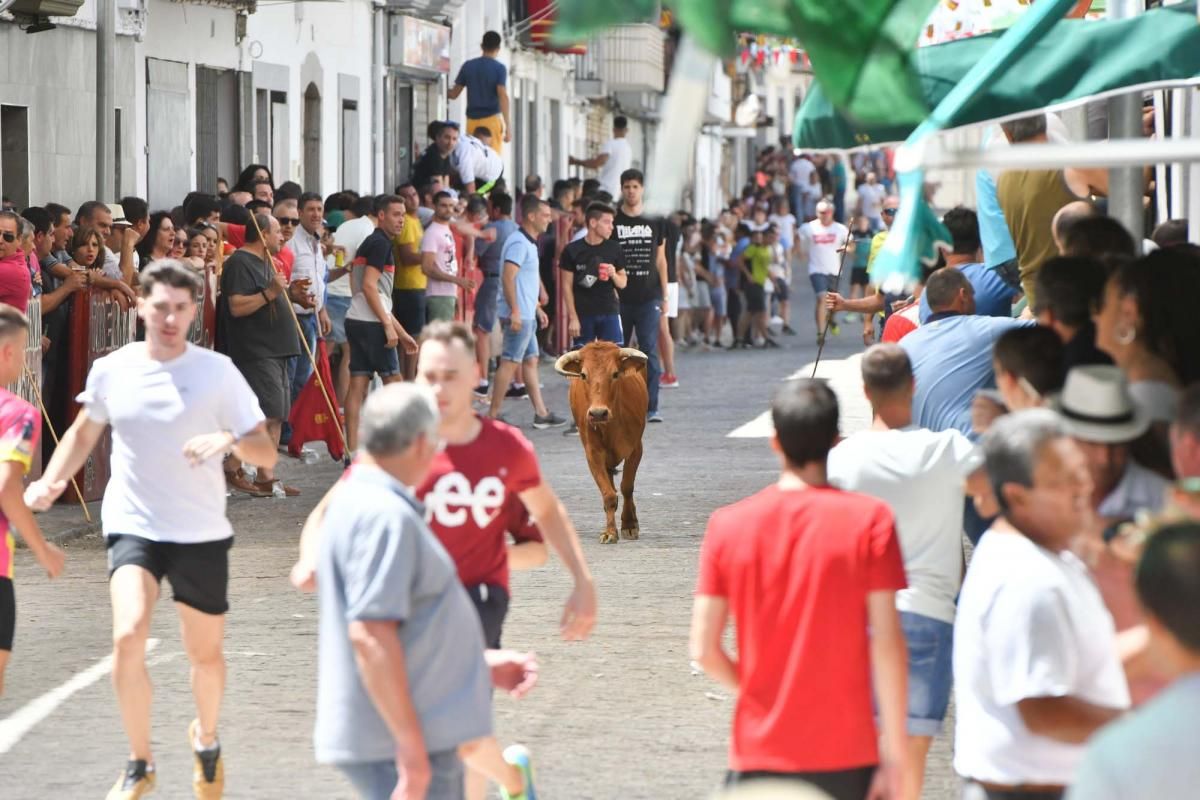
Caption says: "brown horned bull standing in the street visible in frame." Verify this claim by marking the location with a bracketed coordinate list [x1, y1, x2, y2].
[554, 342, 650, 545]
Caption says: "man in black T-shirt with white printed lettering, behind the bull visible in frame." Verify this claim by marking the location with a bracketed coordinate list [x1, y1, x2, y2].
[612, 169, 667, 422]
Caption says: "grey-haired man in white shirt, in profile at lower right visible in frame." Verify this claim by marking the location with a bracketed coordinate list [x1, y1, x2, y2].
[954, 409, 1129, 800]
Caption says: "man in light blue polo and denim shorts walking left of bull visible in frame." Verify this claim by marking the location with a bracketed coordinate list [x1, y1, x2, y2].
[488, 194, 566, 429]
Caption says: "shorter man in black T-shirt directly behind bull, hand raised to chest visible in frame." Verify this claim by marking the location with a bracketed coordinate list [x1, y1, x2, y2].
[558, 203, 629, 348]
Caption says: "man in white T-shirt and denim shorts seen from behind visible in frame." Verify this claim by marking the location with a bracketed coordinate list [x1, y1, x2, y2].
[827, 344, 988, 800]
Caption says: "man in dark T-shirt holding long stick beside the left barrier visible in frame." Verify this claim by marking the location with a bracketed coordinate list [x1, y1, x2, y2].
[218, 215, 300, 497]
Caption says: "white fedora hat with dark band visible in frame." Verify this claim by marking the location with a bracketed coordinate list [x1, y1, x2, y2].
[1052, 365, 1151, 445]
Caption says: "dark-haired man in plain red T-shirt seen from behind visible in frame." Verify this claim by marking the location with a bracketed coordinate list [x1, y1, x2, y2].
[691, 380, 907, 800]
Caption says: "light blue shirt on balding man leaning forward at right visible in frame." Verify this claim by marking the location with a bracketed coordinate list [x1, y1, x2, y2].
[900, 314, 1036, 439]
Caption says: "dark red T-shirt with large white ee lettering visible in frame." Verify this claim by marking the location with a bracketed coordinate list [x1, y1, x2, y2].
[416, 419, 541, 589]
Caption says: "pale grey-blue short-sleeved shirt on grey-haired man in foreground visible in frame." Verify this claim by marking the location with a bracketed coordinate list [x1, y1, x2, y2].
[313, 464, 492, 764]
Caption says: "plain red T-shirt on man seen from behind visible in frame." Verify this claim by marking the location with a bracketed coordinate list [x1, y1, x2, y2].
[696, 486, 905, 772]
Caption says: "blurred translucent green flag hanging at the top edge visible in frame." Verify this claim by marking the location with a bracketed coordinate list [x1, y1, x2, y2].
[552, 0, 937, 125]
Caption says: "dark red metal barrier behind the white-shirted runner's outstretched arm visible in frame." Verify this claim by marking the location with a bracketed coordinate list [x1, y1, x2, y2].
[59, 289, 137, 503]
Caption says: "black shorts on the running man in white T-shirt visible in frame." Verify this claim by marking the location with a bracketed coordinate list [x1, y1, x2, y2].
[104, 534, 233, 614]
